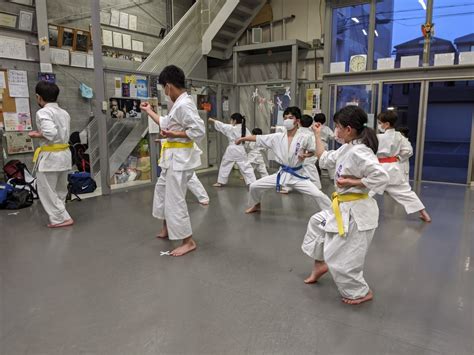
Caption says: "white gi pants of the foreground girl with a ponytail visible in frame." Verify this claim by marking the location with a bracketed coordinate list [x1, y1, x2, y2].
[301, 211, 375, 299]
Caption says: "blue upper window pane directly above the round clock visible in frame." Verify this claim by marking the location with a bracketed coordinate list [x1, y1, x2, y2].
[331, 4, 370, 71]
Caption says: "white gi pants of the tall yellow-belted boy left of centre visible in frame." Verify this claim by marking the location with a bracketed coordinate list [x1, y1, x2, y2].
[153, 168, 194, 240]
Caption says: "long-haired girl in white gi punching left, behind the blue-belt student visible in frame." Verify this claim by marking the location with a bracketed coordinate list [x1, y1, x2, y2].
[209, 113, 256, 187]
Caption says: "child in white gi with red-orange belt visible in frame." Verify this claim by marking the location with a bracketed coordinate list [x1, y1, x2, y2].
[377, 111, 431, 222]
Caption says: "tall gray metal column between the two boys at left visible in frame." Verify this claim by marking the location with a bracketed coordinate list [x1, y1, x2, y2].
[90, 0, 110, 195]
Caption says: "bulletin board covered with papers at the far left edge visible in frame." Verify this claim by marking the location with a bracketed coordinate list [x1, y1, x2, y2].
[0, 69, 34, 154]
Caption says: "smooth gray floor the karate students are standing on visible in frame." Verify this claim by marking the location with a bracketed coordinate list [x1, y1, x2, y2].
[0, 176, 474, 355]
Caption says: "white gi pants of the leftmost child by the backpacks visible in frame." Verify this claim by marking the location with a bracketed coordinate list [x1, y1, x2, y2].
[36, 171, 71, 224]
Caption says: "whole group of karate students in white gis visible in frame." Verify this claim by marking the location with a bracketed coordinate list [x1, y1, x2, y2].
[30, 65, 431, 304]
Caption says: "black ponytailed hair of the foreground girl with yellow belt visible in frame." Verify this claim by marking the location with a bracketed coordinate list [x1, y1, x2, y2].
[334, 105, 379, 154]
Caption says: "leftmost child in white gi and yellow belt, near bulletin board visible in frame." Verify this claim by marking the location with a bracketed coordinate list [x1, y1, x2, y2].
[28, 81, 74, 228]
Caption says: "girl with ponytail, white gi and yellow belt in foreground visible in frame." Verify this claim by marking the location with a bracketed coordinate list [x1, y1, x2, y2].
[301, 106, 389, 304]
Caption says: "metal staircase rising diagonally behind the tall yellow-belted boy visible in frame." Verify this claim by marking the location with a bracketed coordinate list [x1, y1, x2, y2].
[87, 0, 266, 184]
